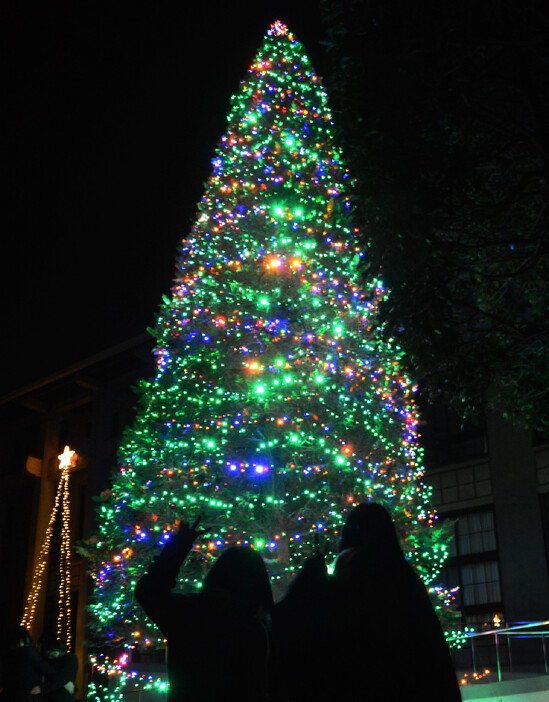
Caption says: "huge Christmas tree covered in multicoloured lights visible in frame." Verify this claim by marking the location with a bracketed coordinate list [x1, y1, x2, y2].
[83, 22, 460, 700]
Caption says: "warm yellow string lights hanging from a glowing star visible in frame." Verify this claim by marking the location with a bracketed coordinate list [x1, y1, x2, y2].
[21, 446, 76, 650]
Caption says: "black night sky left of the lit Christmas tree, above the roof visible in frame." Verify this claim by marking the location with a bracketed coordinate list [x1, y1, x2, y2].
[0, 0, 322, 396]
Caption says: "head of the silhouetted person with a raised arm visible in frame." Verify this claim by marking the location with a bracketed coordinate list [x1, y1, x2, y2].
[204, 546, 273, 612]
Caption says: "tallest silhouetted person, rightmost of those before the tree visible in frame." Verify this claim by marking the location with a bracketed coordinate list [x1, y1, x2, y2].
[334, 503, 461, 702]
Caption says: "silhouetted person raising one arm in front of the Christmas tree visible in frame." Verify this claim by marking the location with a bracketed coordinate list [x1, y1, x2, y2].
[135, 519, 273, 702]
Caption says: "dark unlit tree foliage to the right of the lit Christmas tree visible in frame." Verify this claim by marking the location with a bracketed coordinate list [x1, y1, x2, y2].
[321, 0, 549, 430]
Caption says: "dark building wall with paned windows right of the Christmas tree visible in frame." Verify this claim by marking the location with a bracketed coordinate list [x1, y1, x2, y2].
[422, 407, 549, 666]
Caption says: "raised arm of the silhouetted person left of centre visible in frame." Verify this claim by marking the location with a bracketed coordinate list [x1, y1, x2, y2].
[135, 518, 200, 634]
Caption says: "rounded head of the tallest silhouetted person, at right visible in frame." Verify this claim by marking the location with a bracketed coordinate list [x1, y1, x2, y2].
[339, 502, 400, 552]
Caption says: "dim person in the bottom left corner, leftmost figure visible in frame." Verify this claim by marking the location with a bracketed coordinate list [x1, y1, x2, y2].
[0, 626, 53, 702]
